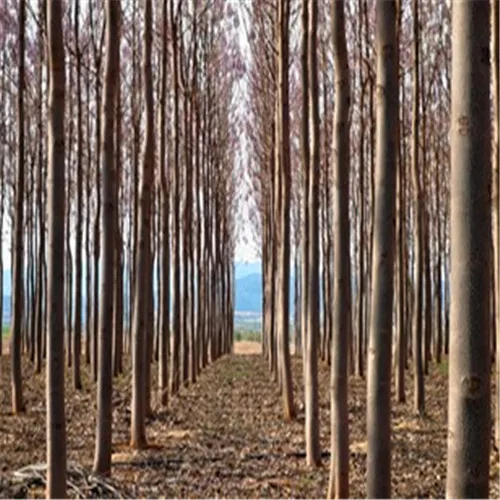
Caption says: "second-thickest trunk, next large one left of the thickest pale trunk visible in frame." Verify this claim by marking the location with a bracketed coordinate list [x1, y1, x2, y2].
[367, 0, 399, 498]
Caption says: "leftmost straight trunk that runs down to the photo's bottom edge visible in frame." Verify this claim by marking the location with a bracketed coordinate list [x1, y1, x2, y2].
[47, 1, 66, 492]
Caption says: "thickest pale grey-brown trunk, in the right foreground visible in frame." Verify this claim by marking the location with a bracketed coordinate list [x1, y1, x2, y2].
[446, 0, 492, 498]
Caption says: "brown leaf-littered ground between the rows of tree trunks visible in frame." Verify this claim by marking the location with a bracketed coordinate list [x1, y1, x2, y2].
[0, 342, 499, 498]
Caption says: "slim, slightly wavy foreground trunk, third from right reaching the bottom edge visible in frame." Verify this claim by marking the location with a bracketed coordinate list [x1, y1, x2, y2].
[328, 0, 351, 498]
